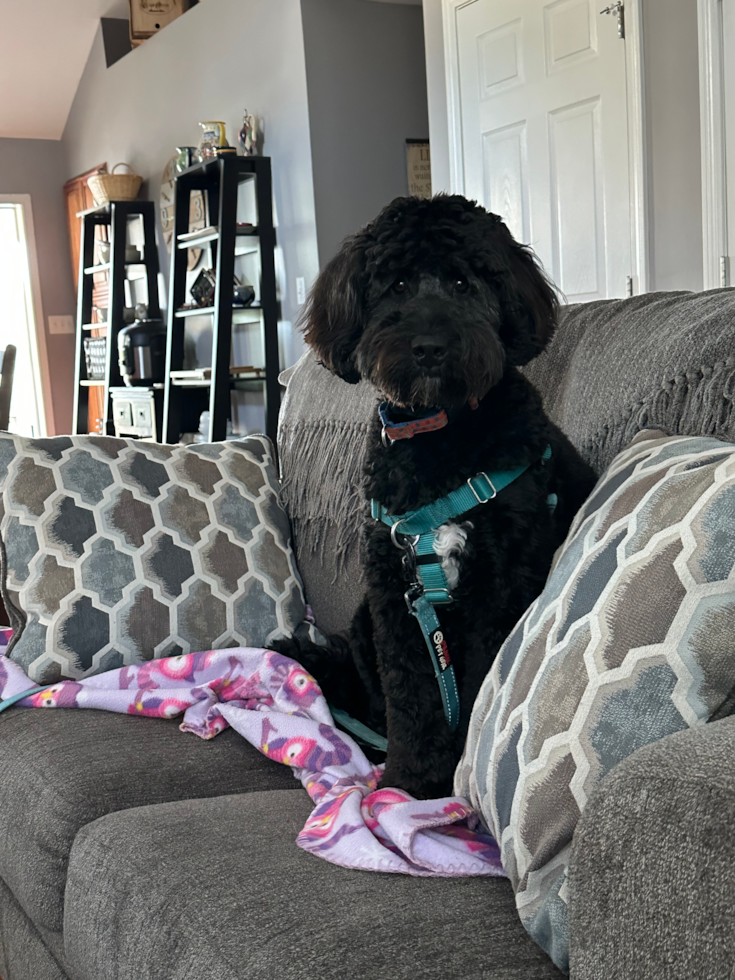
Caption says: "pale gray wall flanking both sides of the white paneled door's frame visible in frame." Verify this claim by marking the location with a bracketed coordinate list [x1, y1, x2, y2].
[423, 0, 702, 289]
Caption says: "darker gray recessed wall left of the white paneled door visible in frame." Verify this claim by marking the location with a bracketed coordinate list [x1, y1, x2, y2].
[301, 0, 429, 264]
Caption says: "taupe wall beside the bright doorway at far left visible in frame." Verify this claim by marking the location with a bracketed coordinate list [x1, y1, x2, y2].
[0, 139, 76, 432]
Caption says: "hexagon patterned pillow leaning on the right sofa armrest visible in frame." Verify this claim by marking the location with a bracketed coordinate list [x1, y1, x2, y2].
[454, 431, 735, 970]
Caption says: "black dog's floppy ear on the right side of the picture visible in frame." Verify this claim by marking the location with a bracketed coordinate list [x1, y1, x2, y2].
[496, 222, 559, 366]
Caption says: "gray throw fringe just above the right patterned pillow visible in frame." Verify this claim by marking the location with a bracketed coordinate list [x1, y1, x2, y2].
[581, 357, 735, 473]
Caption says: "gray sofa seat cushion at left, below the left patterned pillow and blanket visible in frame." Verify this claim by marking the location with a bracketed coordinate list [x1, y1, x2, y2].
[0, 708, 300, 947]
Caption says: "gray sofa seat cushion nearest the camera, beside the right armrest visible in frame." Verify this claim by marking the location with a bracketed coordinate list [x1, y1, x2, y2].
[64, 791, 562, 980]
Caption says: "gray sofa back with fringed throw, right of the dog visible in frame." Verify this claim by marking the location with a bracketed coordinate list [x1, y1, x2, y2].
[524, 289, 735, 473]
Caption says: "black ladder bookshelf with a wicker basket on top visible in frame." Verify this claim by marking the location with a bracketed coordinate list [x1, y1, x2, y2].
[72, 201, 163, 435]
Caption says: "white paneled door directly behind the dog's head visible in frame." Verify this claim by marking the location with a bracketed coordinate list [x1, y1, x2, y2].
[453, 0, 634, 303]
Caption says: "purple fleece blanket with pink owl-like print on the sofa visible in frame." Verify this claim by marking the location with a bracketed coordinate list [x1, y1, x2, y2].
[0, 648, 504, 877]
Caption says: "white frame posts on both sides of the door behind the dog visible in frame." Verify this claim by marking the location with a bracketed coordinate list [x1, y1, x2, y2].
[442, 0, 648, 294]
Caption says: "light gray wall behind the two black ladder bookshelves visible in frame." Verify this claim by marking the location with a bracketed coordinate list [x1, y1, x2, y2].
[63, 0, 318, 372]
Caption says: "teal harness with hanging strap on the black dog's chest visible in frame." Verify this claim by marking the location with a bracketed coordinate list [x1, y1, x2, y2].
[371, 446, 556, 732]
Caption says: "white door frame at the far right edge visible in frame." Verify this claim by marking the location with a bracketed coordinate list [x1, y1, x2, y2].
[697, 0, 730, 289]
